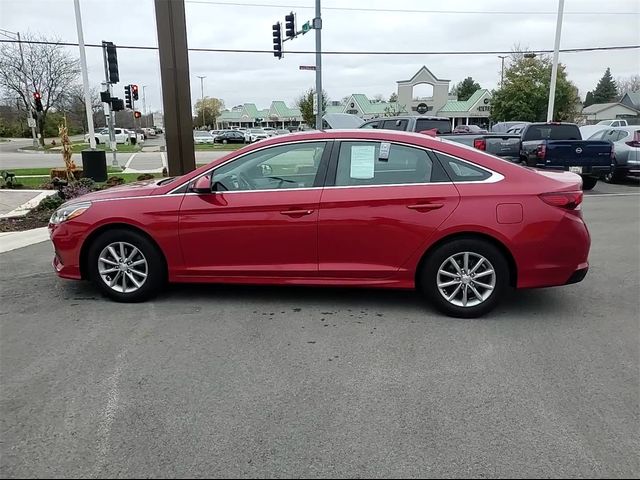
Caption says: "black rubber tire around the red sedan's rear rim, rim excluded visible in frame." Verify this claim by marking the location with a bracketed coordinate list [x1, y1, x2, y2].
[419, 238, 509, 318]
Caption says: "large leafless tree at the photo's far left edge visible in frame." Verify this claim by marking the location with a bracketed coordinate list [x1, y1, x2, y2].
[0, 34, 80, 145]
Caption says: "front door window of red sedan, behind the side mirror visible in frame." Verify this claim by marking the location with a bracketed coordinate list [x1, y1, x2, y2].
[213, 142, 326, 191]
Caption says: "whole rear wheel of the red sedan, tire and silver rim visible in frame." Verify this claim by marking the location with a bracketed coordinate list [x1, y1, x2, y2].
[420, 238, 509, 318]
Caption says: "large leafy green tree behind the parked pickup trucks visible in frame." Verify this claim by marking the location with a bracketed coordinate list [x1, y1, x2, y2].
[491, 51, 580, 122]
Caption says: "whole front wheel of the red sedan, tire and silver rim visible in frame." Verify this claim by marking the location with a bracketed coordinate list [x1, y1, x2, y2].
[88, 229, 166, 302]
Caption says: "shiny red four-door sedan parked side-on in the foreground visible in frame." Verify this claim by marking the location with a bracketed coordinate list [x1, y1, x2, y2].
[49, 130, 590, 317]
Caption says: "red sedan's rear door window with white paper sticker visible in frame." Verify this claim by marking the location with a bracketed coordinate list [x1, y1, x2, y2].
[335, 142, 447, 186]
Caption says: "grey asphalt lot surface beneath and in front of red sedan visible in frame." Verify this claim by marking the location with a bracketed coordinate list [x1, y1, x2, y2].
[0, 182, 640, 478]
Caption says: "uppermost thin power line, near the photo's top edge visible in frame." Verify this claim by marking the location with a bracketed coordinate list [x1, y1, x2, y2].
[185, 0, 638, 16]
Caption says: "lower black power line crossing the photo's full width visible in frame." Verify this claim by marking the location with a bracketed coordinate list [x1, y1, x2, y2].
[0, 39, 640, 55]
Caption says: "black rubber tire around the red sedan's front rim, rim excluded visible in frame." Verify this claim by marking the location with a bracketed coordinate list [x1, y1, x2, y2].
[87, 228, 167, 303]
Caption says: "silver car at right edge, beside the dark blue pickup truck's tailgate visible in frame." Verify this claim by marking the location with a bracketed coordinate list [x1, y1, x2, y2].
[589, 125, 640, 183]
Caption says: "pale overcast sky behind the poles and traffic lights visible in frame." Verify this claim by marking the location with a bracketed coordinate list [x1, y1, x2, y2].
[0, 0, 640, 110]
